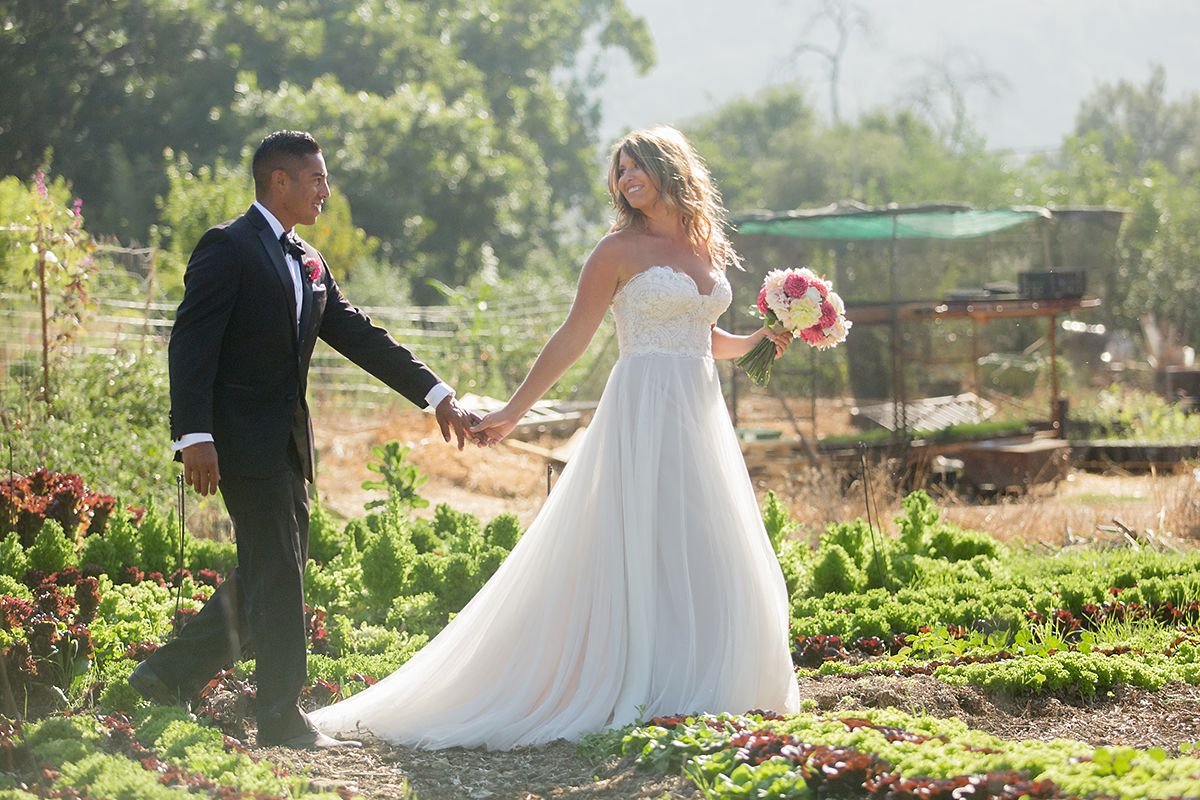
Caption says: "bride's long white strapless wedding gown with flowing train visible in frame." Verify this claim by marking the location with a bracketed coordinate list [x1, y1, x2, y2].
[311, 266, 799, 750]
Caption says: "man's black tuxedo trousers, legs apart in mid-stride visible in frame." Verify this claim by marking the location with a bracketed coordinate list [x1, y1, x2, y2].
[142, 443, 308, 739]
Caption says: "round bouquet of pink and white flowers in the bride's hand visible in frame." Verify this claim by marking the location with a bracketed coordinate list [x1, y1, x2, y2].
[738, 266, 851, 386]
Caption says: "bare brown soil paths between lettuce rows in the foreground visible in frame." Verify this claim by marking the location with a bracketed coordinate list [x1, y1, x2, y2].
[256, 676, 1200, 800]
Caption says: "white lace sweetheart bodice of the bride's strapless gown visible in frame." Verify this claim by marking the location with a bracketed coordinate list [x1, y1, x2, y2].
[612, 266, 733, 357]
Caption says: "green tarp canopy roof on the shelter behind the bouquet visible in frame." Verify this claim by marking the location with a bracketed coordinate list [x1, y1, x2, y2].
[731, 204, 1052, 241]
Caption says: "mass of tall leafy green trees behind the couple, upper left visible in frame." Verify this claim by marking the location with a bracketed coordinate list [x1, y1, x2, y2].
[0, 0, 653, 293]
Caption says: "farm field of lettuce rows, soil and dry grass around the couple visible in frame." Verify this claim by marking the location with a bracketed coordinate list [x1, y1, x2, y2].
[0, 402, 1200, 800]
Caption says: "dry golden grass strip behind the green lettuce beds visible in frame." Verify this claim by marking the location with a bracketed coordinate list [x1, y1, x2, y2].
[304, 397, 1200, 547]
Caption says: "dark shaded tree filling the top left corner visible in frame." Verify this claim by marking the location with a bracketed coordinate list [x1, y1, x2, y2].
[0, 0, 234, 237]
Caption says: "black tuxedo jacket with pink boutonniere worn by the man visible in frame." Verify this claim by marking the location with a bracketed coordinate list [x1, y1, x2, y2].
[168, 206, 438, 480]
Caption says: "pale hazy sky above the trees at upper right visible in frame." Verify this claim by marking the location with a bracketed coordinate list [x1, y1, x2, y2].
[600, 0, 1200, 154]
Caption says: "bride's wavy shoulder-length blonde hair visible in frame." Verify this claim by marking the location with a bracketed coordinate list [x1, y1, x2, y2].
[608, 125, 742, 269]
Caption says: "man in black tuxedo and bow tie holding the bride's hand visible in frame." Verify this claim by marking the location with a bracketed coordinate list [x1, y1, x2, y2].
[130, 131, 478, 748]
